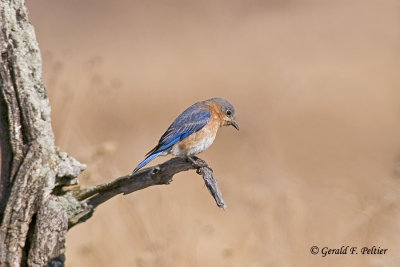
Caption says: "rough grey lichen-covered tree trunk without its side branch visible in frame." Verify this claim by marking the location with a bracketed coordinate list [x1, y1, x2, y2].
[0, 0, 84, 266]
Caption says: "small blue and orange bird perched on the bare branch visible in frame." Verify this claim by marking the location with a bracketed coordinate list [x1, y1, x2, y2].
[132, 97, 239, 173]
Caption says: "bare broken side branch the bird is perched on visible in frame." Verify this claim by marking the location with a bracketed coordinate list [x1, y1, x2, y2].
[68, 157, 226, 227]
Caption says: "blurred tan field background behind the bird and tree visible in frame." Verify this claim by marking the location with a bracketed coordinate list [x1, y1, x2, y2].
[27, 0, 400, 267]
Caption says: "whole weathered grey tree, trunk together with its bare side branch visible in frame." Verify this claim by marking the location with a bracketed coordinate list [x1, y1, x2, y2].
[0, 0, 226, 266]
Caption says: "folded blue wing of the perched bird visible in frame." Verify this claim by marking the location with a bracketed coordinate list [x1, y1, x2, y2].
[147, 106, 211, 155]
